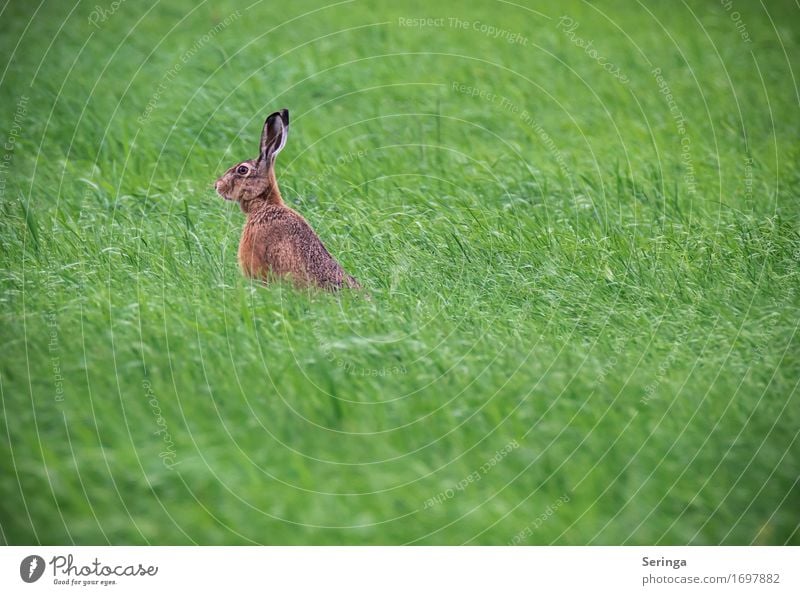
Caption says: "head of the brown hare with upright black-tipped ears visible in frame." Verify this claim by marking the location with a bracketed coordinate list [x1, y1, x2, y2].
[214, 109, 289, 212]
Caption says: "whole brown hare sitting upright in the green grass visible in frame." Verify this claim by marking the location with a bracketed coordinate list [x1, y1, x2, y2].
[214, 109, 361, 290]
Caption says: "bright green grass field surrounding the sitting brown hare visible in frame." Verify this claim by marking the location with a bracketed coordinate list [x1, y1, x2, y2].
[0, 0, 800, 545]
